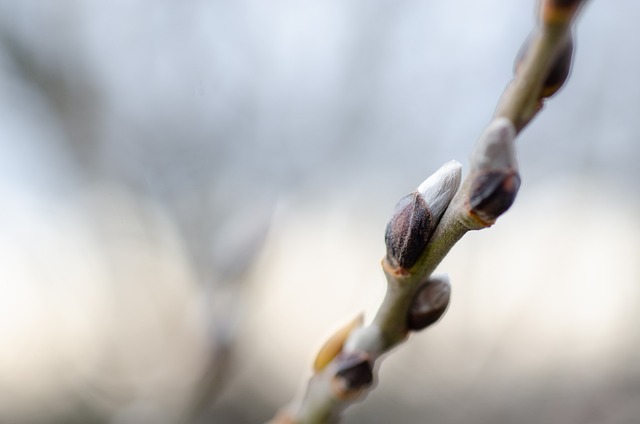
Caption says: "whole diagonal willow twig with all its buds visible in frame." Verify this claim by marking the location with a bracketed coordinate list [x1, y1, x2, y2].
[271, 0, 584, 424]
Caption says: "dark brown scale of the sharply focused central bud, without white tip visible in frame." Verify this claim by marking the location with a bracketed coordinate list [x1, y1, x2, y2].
[385, 192, 435, 268]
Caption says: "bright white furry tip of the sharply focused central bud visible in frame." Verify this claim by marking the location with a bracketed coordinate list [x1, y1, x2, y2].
[418, 160, 462, 219]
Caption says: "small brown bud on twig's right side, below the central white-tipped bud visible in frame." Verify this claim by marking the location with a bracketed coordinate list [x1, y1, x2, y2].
[407, 276, 451, 331]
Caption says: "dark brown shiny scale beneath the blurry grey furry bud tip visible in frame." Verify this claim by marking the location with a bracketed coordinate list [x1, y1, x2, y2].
[469, 170, 520, 223]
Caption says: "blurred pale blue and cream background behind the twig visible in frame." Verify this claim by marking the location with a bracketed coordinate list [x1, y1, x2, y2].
[0, 0, 640, 424]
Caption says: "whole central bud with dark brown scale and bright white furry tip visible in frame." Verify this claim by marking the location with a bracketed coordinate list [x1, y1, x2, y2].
[385, 161, 461, 269]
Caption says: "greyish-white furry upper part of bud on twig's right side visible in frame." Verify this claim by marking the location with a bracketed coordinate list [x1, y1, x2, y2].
[471, 118, 518, 171]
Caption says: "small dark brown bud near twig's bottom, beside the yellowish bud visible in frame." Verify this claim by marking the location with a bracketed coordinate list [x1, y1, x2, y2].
[333, 352, 373, 397]
